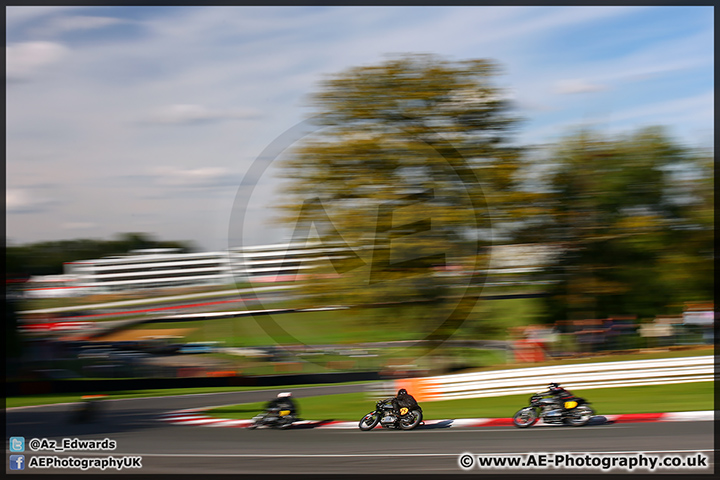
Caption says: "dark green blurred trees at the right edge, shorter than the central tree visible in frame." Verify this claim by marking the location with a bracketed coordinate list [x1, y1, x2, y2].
[526, 127, 714, 320]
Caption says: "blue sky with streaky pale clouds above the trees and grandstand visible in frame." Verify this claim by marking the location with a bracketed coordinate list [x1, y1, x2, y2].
[6, 7, 714, 250]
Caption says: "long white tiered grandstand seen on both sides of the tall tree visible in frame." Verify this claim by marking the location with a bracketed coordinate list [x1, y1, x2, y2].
[53, 242, 554, 296]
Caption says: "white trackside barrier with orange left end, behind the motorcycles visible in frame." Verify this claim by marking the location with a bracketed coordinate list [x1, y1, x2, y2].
[370, 355, 715, 402]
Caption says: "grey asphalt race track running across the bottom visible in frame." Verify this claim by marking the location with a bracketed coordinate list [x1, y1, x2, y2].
[6, 385, 714, 475]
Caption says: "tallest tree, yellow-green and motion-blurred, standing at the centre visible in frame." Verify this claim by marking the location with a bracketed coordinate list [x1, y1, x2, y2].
[272, 55, 529, 342]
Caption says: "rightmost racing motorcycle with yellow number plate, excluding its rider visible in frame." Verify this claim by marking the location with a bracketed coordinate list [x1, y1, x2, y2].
[513, 393, 595, 428]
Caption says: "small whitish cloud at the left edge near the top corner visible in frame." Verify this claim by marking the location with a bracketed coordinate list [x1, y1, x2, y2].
[5, 42, 68, 80]
